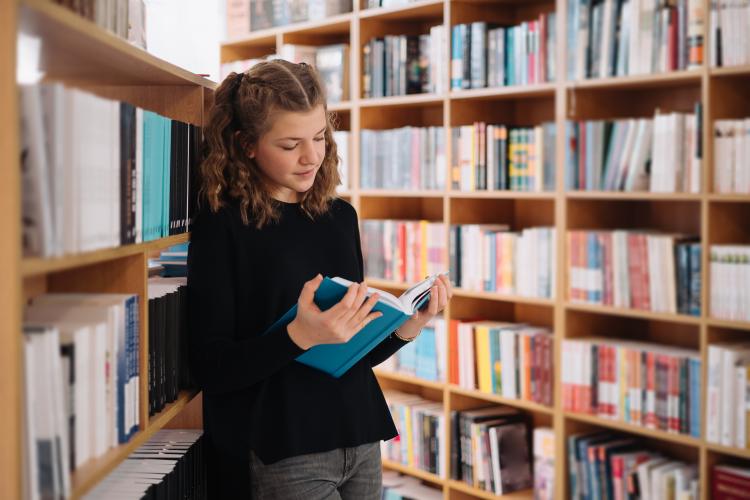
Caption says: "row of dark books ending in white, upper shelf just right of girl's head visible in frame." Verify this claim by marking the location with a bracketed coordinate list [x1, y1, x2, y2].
[362, 25, 445, 98]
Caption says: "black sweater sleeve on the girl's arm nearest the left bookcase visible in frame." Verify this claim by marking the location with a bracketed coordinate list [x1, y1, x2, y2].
[188, 210, 304, 394]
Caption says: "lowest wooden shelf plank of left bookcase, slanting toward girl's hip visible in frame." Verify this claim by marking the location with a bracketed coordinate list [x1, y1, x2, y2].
[72, 391, 197, 499]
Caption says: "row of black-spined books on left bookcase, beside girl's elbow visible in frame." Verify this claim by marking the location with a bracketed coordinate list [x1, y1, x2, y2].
[148, 276, 194, 416]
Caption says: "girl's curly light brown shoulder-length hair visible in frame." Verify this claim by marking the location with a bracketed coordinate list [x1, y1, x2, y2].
[198, 60, 340, 228]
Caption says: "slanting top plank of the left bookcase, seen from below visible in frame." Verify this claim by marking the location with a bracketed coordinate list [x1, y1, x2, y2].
[19, 0, 216, 89]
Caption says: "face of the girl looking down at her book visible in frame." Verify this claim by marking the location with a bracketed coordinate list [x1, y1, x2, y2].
[248, 106, 326, 203]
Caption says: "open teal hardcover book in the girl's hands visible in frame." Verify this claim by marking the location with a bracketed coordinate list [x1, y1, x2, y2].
[264, 274, 446, 378]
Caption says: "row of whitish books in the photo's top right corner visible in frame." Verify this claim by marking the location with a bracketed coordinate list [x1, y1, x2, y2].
[710, 0, 750, 66]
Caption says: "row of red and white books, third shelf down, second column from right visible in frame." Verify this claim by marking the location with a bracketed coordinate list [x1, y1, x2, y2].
[567, 230, 701, 316]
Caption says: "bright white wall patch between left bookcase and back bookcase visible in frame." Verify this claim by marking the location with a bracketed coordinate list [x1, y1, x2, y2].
[145, 0, 226, 81]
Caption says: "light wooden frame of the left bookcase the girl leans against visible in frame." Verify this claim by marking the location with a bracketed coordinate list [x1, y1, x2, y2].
[0, 0, 215, 499]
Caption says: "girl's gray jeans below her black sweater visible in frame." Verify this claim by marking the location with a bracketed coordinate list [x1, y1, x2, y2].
[250, 441, 383, 500]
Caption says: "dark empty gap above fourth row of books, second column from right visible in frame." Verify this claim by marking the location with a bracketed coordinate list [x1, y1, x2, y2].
[565, 309, 700, 351]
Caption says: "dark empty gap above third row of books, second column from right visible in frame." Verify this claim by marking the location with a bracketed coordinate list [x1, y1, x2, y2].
[567, 199, 701, 236]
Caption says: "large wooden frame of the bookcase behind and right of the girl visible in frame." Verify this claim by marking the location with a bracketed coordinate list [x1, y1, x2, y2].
[221, 0, 750, 500]
